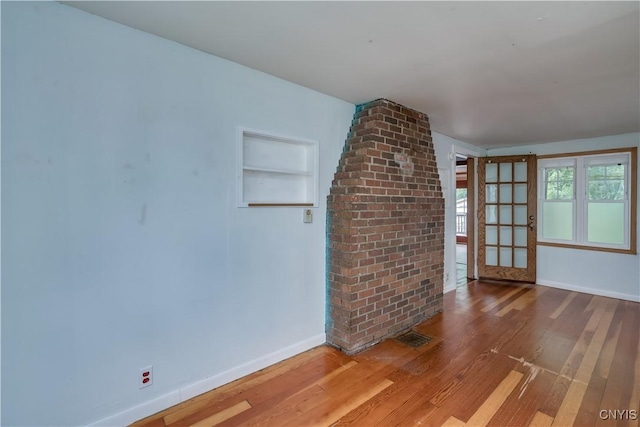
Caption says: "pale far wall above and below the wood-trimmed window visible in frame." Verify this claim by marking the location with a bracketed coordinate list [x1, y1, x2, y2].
[489, 133, 640, 301]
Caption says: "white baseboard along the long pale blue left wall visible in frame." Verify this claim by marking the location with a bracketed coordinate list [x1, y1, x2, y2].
[90, 334, 327, 426]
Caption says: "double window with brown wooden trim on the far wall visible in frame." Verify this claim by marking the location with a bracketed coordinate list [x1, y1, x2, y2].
[538, 148, 637, 253]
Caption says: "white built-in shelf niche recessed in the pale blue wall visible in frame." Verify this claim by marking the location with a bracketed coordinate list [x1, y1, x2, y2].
[238, 128, 318, 207]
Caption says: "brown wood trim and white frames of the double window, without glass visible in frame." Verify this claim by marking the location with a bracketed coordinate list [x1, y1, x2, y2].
[536, 147, 638, 255]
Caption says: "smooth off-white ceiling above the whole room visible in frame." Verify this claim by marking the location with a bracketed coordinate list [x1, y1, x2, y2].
[61, 1, 640, 148]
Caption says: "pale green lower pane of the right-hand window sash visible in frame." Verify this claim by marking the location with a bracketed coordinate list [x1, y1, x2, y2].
[587, 202, 624, 245]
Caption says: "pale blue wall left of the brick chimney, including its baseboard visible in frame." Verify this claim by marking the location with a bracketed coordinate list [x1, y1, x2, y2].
[2, 2, 354, 425]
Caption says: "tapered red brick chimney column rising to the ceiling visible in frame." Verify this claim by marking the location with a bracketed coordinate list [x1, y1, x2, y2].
[327, 99, 444, 352]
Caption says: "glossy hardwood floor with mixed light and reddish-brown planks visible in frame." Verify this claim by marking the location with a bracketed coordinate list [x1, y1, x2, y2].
[134, 281, 640, 427]
